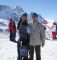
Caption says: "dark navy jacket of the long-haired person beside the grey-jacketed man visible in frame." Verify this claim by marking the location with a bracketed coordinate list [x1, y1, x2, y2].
[17, 21, 29, 45]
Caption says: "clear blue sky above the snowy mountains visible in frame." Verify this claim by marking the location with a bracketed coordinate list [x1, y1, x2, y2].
[0, 0, 57, 19]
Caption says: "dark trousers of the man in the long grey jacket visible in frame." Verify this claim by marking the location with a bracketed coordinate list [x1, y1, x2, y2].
[29, 45, 41, 60]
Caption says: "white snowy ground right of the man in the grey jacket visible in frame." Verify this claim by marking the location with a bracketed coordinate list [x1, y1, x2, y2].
[41, 40, 57, 60]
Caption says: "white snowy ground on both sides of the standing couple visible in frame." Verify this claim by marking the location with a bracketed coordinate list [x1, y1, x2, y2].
[0, 33, 57, 60]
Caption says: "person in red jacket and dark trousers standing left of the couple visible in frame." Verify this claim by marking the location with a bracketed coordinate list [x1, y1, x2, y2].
[9, 19, 16, 42]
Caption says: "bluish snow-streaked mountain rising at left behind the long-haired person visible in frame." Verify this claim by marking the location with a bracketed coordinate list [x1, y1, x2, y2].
[0, 5, 24, 20]
